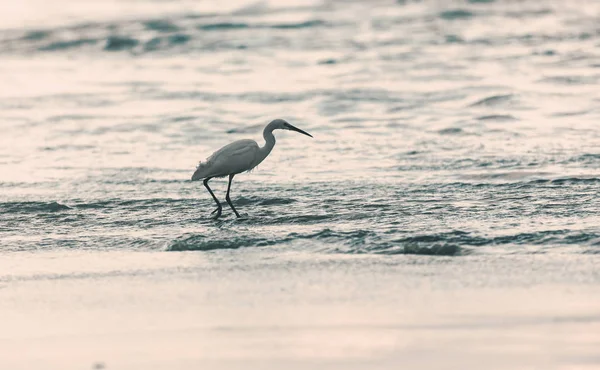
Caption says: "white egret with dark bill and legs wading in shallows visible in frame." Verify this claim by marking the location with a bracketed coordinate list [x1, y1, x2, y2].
[192, 119, 312, 219]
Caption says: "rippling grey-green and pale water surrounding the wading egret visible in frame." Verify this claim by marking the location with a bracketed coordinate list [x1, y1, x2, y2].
[0, 0, 600, 363]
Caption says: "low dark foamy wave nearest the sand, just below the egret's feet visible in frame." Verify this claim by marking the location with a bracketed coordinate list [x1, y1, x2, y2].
[167, 228, 600, 256]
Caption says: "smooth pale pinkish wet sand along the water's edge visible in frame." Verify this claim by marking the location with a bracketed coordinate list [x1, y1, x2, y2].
[0, 248, 600, 370]
